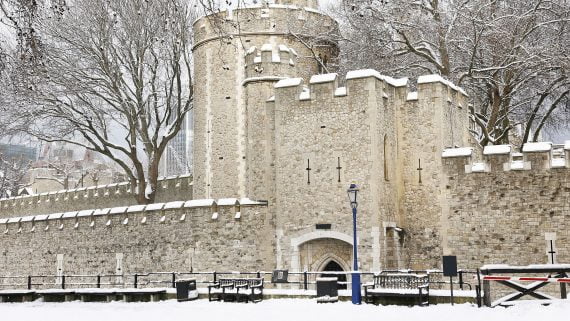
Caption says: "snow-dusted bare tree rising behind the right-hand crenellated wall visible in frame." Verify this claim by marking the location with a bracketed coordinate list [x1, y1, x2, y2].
[337, 0, 570, 145]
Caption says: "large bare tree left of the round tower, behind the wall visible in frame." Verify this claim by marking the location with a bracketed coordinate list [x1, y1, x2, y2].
[18, 0, 195, 204]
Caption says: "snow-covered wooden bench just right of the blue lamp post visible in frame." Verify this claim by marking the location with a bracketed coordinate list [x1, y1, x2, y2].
[364, 273, 429, 306]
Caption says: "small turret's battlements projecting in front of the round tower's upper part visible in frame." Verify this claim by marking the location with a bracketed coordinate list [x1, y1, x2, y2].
[245, 44, 299, 83]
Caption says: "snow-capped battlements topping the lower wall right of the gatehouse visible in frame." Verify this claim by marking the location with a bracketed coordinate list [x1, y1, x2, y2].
[442, 141, 570, 174]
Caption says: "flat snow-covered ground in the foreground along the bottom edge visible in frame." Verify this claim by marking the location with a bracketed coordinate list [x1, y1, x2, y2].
[0, 299, 570, 321]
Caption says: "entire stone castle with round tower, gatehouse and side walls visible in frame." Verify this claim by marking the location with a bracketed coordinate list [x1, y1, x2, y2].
[0, 0, 570, 275]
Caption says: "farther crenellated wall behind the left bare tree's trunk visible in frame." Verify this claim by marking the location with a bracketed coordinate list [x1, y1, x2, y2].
[0, 175, 192, 218]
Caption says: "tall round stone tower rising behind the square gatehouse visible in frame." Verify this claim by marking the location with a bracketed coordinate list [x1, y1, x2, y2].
[193, 0, 338, 198]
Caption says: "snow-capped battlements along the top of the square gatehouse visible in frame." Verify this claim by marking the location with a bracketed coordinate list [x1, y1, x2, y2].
[270, 69, 468, 108]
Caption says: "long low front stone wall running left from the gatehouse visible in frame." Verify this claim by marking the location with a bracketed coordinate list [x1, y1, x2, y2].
[0, 200, 275, 275]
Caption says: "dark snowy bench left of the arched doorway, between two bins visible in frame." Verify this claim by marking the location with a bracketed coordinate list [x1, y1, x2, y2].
[208, 278, 263, 303]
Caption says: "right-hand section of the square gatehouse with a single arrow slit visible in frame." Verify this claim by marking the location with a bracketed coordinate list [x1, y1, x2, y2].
[399, 76, 469, 269]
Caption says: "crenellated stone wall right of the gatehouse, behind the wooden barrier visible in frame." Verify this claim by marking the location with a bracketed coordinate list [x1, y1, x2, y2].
[444, 143, 570, 268]
